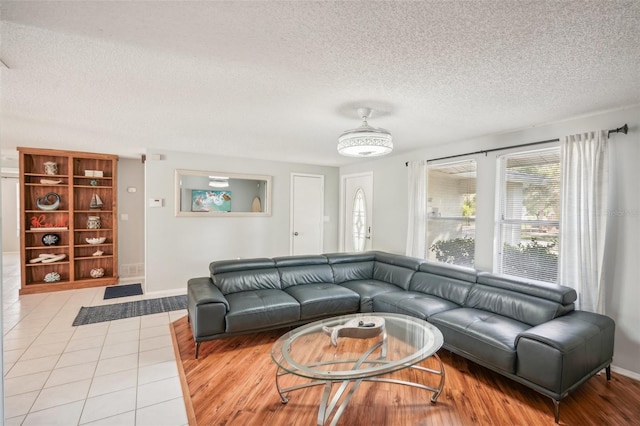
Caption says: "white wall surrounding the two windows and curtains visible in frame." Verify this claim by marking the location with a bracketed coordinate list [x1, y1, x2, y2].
[340, 106, 640, 376]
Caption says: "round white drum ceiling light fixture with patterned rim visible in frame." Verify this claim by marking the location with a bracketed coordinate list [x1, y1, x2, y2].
[338, 108, 393, 157]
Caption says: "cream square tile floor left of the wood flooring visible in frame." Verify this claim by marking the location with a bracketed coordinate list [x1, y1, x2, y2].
[2, 253, 188, 426]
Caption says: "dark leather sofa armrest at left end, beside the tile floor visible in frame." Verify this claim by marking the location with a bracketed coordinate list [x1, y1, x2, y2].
[187, 277, 229, 342]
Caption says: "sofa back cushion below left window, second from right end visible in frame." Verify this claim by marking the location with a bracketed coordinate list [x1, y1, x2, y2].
[409, 262, 476, 305]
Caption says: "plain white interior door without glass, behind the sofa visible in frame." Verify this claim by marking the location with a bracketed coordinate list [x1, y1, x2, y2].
[290, 173, 324, 255]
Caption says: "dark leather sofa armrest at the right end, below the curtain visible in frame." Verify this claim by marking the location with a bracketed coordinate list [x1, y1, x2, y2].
[516, 311, 615, 400]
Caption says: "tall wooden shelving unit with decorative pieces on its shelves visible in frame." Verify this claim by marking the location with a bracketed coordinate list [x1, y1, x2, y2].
[18, 147, 118, 294]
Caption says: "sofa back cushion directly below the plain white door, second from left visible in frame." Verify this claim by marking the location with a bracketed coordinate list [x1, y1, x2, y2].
[274, 256, 333, 288]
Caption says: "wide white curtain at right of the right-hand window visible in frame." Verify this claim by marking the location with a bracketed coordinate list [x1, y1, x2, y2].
[559, 130, 609, 313]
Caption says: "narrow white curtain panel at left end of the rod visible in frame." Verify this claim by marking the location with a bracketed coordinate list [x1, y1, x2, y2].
[406, 160, 427, 259]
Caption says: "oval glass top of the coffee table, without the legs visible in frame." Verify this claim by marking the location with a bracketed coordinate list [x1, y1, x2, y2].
[271, 312, 443, 381]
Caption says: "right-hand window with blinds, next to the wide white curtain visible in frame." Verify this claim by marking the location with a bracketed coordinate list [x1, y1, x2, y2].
[494, 147, 560, 282]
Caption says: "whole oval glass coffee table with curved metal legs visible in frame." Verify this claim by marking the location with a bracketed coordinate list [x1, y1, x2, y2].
[271, 312, 445, 425]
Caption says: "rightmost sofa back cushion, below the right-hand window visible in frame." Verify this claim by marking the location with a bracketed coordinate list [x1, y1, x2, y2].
[464, 273, 575, 326]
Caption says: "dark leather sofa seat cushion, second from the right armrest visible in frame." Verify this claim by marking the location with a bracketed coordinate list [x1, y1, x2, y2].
[373, 291, 460, 320]
